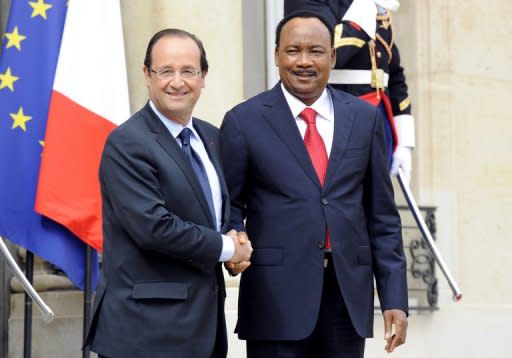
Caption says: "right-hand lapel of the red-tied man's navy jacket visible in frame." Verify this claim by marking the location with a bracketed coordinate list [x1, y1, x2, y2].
[324, 87, 354, 188]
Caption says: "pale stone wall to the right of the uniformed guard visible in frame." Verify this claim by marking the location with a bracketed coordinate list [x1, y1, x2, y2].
[378, 0, 512, 358]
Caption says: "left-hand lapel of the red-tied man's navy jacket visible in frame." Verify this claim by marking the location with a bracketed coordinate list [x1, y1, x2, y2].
[264, 83, 322, 189]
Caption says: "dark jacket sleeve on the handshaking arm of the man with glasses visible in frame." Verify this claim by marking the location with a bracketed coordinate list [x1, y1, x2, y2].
[100, 130, 222, 271]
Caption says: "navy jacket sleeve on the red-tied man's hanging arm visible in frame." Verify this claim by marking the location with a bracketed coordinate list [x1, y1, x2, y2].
[364, 110, 408, 312]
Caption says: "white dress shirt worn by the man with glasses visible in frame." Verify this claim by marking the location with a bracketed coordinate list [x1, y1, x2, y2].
[149, 101, 235, 262]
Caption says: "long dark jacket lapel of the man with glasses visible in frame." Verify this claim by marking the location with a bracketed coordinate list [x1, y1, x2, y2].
[143, 104, 215, 227]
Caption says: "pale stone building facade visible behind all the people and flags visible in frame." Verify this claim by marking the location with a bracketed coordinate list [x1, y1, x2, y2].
[0, 0, 512, 358]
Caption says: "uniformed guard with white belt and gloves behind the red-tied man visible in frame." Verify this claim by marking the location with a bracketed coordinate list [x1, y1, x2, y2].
[284, 0, 415, 181]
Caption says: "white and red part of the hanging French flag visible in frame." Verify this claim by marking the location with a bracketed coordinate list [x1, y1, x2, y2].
[35, 0, 130, 251]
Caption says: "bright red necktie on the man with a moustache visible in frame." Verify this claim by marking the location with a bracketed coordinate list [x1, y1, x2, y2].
[299, 108, 331, 249]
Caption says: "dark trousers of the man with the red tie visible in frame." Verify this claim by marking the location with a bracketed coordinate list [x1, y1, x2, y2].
[247, 261, 365, 358]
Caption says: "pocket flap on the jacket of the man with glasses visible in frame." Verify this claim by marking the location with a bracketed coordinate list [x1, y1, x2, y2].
[132, 282, 189, 300]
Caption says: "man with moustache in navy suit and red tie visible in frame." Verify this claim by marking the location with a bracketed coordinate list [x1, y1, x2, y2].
[221, 12, 408, 358]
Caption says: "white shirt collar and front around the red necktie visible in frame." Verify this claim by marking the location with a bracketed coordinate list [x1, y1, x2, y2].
[281, 83, 334, 157]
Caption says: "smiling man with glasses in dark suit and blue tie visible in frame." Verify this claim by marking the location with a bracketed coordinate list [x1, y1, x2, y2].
[86, 29, 252, 358]
